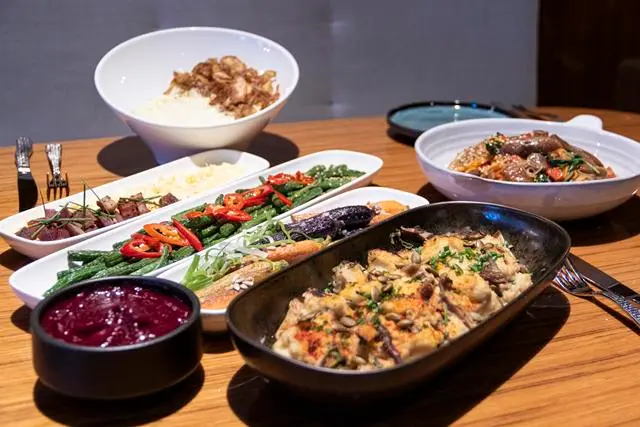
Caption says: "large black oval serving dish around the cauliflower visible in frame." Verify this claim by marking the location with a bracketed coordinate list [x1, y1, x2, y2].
[227, 202, 571, 397]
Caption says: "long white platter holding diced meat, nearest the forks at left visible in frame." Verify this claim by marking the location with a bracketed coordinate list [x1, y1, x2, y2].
[0, 149, 269, 259]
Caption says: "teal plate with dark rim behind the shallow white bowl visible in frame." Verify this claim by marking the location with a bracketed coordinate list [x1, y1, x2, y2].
[387, 101, 518, 139]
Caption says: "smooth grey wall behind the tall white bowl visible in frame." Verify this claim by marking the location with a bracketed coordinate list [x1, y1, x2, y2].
[0, 0, 538, 145]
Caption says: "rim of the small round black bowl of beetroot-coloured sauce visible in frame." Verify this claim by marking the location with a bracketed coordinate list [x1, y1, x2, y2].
[29, 276, 200, 353]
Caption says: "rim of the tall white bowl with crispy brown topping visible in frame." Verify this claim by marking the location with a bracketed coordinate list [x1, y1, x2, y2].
[93, 27, 300, 129]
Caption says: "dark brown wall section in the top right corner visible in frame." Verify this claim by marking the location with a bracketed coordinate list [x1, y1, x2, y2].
[538, 0, 640, 112]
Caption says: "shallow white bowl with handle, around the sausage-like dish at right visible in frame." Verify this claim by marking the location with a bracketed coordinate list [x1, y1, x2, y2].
[415, 115, 640, 221]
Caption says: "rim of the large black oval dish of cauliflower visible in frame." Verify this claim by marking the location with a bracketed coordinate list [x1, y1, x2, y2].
[225, 201, 571, 377]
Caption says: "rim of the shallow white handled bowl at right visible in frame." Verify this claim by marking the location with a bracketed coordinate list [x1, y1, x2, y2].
[415, 116, 640, 188]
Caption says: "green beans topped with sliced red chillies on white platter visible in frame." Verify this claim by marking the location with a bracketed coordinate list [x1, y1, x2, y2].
[46, 165, 364, 295]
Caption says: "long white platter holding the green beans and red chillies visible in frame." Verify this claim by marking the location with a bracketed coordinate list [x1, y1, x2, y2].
[9, 150, 382, 307]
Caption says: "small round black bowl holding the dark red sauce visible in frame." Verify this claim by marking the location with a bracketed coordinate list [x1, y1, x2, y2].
[30, 277, 202, 399]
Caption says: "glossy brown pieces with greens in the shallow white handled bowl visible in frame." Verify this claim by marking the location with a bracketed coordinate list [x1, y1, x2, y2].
[449, 130, 615, 182]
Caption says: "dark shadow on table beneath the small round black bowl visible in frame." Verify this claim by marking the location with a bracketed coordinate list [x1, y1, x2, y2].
[33, 366, 204, 426]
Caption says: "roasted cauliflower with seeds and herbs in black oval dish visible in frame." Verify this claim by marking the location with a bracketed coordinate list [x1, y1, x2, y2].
[272, 227, 532, 371]
